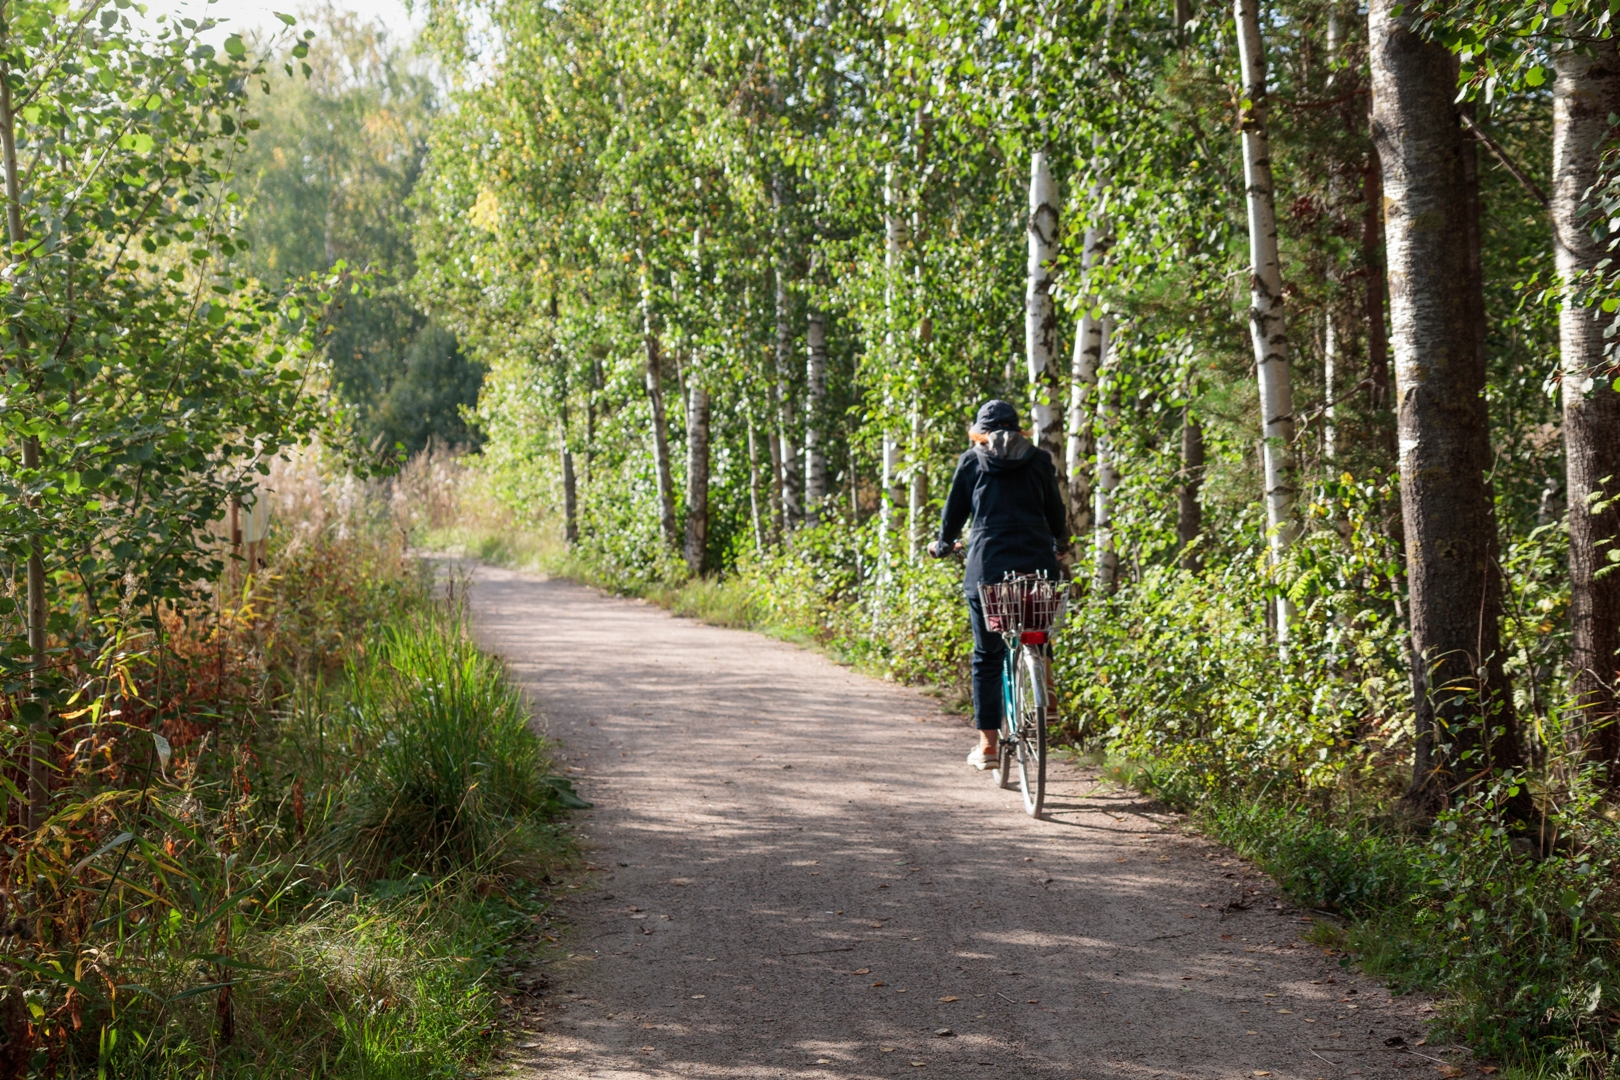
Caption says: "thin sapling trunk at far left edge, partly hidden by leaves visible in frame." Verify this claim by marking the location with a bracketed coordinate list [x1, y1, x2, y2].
[0, 57, 53, 831]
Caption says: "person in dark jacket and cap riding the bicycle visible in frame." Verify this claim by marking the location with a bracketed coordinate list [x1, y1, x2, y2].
[928, 402, 1069, 769]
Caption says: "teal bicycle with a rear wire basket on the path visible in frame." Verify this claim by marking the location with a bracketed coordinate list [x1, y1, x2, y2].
[978, 573, 1069, 818]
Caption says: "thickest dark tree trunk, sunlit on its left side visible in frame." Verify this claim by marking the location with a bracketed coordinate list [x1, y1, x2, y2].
[1367, 0, 1531, 818]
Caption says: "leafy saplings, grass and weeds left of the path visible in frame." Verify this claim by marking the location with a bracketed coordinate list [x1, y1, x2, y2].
[0, 8, 582, 1080]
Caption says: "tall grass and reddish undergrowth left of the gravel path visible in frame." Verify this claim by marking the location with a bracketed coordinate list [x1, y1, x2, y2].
[0, 453, 583, 1080]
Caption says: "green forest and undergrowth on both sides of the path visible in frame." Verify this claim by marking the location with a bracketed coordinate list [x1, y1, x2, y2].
[9, 0, 1620, 1077]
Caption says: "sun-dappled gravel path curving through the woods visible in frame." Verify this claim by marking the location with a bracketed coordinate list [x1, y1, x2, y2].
[470, 568, 1451, 1080]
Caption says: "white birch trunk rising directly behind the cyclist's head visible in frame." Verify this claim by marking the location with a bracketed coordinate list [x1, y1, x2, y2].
[1024, 151, 1068, 502]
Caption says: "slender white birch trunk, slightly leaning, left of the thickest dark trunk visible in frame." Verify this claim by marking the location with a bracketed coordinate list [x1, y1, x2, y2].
[1236, 0, 1299, 641]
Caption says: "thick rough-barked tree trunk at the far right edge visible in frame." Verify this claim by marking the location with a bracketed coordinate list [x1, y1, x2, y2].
[1552, 37, 1620, 785]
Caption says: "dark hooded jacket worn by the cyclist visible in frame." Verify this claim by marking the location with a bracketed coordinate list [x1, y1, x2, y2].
[940, 431, 1069, 596]
